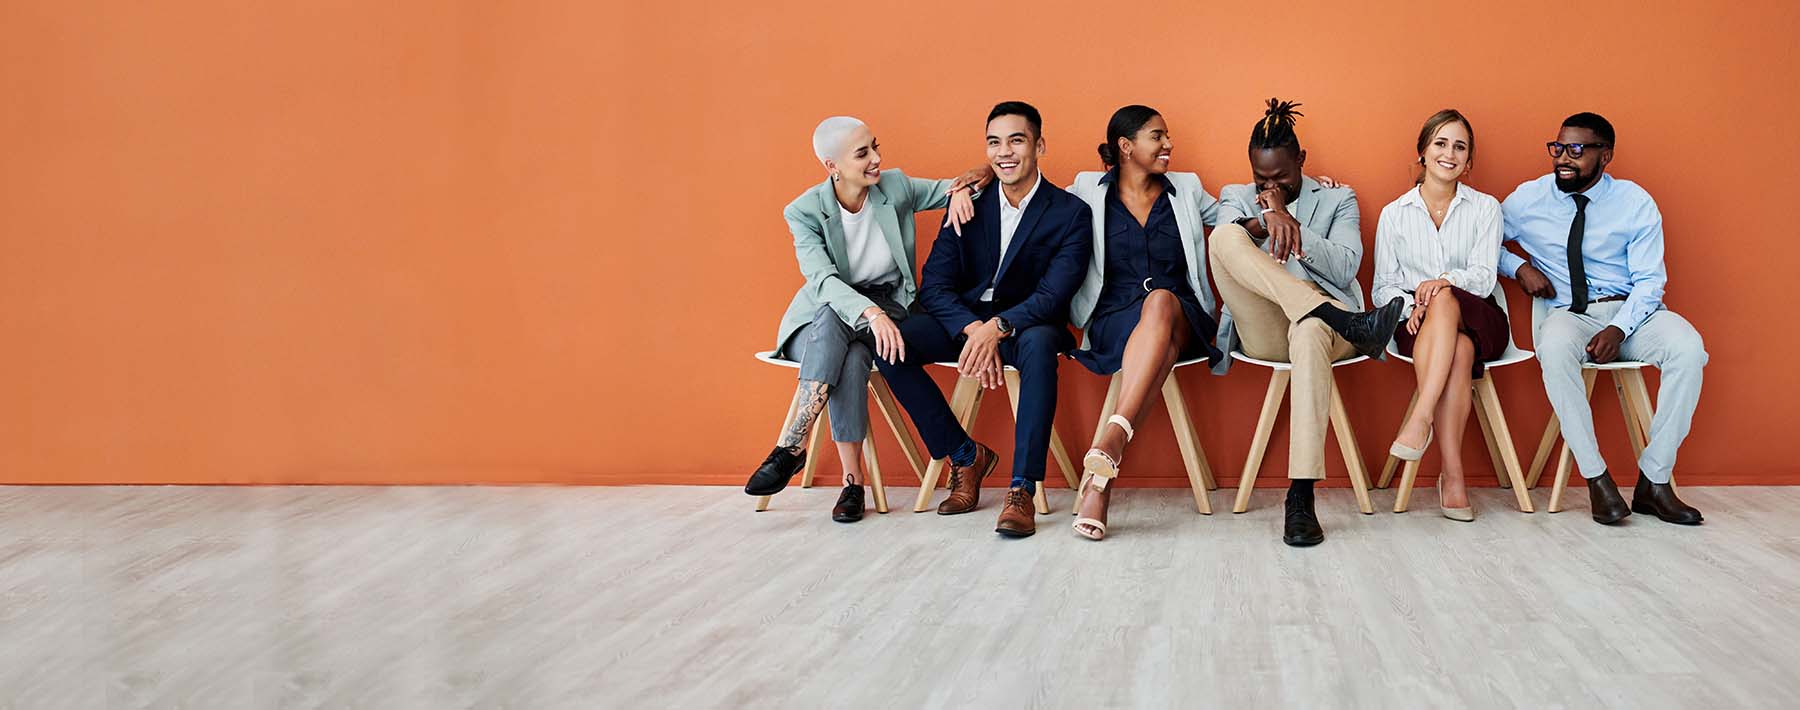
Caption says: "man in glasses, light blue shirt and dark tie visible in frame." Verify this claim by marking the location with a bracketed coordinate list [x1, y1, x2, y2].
[1499, 114, 1706, 524]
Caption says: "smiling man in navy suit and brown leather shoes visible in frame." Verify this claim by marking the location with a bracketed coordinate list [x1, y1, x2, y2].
[875, 101, 1093, 537]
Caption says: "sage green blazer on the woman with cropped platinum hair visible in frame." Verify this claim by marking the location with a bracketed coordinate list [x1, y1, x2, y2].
[776, 169, 954, 353]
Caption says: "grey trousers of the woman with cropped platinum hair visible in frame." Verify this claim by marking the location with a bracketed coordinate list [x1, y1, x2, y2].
[787, 306, 875, 443]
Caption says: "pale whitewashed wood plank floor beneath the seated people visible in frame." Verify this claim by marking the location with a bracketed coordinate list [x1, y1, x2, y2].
[0, 487, 1800, 708]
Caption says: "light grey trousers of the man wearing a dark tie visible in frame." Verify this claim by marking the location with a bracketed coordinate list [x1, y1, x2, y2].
[1535, 301, 1706, 483]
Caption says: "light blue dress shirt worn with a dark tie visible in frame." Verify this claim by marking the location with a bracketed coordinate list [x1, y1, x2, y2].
[1499, 173, 1669, 335]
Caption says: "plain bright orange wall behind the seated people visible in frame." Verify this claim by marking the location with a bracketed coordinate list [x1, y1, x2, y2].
[0, 2, 1800, 485]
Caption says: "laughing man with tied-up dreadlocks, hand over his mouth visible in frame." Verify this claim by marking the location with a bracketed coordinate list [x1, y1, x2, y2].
[1208, 99, 1402, 546]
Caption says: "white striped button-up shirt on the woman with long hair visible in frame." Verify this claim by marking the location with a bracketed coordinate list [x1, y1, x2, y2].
[1370, 182, 1503, 310]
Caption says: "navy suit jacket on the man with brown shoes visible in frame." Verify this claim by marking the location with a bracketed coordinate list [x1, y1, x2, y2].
[918, 175, 1094, 342]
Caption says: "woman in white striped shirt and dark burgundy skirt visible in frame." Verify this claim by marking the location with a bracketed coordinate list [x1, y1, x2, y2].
[1372, 108, 1510, 521]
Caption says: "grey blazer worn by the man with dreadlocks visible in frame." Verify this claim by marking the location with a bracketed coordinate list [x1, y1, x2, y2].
[1213, 175, 1366, 375]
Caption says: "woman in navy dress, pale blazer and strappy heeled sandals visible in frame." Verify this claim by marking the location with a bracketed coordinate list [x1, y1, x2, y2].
[1069, 106, 1222, 541]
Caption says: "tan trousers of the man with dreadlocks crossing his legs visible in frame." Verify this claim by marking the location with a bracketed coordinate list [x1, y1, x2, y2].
[1206, 223, 1355, 479]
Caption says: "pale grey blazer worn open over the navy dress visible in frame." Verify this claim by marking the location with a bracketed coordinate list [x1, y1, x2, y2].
[1069, 171, 1219, 350]
